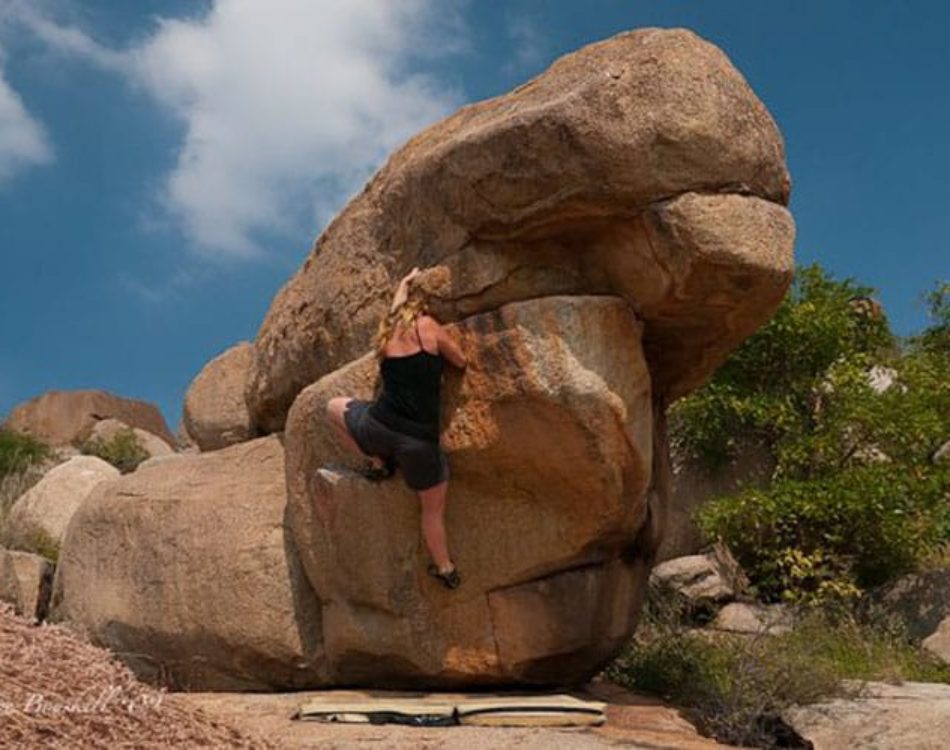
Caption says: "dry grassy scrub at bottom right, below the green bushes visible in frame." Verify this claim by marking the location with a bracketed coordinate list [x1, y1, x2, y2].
[606, 610, 950, 748]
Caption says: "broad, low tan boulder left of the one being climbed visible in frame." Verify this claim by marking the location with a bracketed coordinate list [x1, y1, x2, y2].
[50, 436, 323, 690]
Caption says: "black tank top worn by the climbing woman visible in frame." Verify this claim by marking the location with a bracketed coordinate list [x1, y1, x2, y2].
[369, 320, 445, 442]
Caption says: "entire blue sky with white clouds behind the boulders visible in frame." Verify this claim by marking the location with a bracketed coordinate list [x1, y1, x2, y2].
[0, 0, 950, 429]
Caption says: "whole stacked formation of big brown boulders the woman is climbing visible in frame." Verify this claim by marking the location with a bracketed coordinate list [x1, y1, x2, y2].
[44, 29, 794, 690]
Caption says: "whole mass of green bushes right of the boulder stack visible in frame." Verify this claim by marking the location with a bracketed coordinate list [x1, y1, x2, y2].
[671, 266, 950, 602]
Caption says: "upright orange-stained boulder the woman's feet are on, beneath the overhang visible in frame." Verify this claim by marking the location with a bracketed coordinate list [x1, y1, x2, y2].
[286, 296, 653, 686]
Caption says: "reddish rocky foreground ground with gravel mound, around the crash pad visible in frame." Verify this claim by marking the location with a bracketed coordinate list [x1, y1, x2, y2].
[0, 604, 722, 750]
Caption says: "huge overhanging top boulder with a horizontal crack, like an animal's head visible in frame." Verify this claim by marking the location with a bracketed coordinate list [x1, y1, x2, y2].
[246, 29, 794, 431]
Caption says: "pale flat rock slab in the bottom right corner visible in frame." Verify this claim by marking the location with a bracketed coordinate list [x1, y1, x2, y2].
[782, 682, 950, 750]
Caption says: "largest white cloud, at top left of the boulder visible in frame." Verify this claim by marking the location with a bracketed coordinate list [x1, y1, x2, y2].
[7, 0, 459, 257]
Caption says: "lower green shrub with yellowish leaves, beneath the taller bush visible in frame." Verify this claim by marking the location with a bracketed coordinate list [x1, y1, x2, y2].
[697, 463, 950, 601]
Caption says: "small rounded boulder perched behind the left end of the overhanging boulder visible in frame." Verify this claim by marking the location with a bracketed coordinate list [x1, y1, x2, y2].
[182, 341, 254, 451]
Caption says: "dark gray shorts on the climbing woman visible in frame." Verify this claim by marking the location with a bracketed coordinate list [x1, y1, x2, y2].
[343, 398, 449, 490]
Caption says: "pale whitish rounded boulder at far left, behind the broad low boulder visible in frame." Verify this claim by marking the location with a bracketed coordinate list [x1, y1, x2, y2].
[6, 456, 119, 546]
